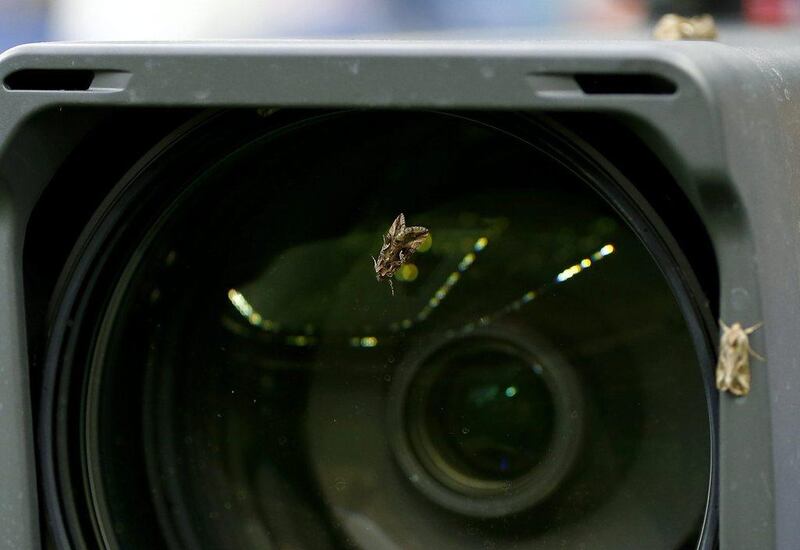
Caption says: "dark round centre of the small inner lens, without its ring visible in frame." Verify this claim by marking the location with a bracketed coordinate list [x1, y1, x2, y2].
[407, 342, 555, 493]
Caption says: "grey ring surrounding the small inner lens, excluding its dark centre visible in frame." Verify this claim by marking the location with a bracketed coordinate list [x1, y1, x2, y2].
[387, 324, 585, 519]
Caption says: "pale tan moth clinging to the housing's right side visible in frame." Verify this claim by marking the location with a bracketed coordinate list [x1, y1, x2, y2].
[717, 321, 764, 395]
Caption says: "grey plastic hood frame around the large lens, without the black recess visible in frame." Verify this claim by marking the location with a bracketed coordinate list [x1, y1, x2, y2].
[0, 41, 800, 549]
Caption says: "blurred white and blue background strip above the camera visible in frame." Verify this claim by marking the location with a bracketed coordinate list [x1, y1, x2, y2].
[0, 0, 800, 51]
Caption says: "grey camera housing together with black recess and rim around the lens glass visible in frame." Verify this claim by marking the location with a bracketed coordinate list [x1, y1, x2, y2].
[0, 41, 800, 548]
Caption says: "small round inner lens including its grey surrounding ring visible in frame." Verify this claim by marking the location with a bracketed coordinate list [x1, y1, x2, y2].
[388, 330, 585, 518]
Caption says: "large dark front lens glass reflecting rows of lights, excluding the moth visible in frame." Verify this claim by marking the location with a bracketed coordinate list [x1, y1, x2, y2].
[76, 112, 710, 549]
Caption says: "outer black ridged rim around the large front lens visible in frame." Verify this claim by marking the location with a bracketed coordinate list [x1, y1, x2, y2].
[37, 110, 718, 548]
